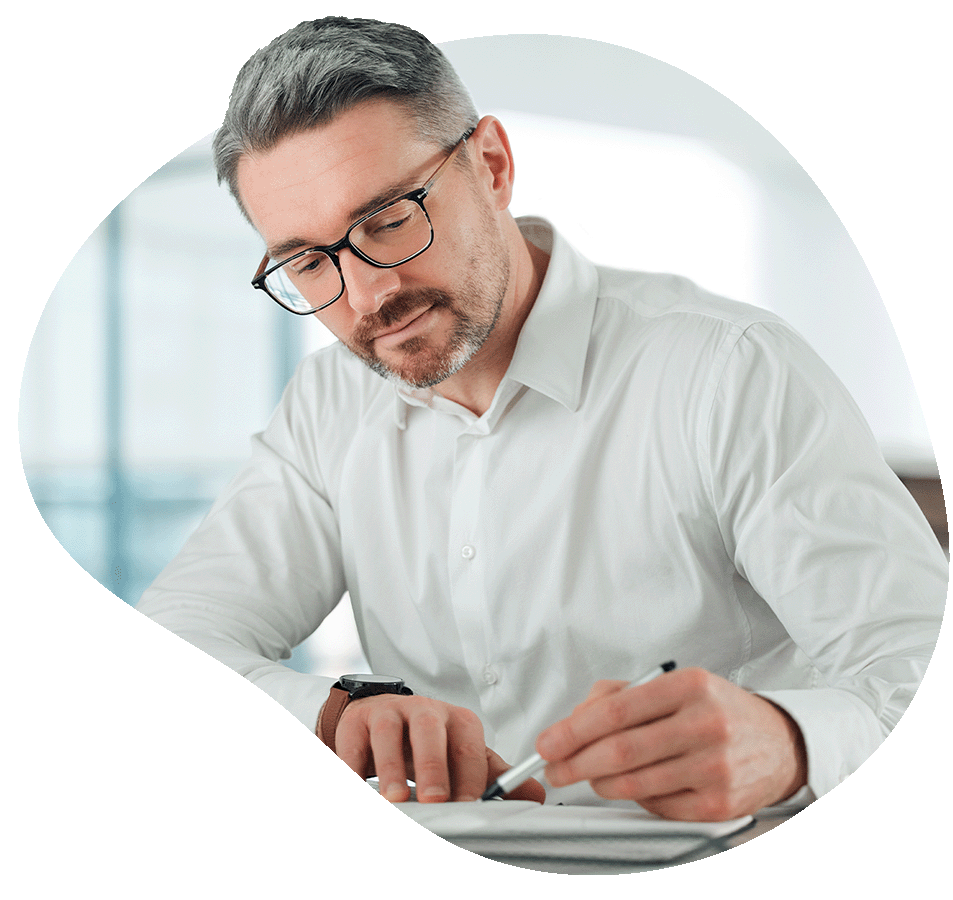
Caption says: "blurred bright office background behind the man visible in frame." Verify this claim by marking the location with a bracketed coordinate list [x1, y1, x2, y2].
[20, 35, 948, 674]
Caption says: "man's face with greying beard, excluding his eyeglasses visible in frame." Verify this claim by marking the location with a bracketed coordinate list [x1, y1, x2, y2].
[238, 102, 509, 387]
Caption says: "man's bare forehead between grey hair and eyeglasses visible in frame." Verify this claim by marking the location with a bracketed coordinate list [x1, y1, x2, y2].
[237, 101, 440, 247]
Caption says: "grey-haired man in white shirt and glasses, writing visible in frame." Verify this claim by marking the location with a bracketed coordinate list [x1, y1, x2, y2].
[139, 19, 946, 820]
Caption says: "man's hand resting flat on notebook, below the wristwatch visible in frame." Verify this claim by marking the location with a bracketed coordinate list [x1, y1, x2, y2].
[334, 694, 546, 803]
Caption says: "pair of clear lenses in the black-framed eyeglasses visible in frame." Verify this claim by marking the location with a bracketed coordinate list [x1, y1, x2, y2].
[265, 199, 431, 312]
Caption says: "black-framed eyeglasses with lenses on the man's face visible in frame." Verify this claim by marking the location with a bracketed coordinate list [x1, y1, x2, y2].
[251, 128, 473, 316]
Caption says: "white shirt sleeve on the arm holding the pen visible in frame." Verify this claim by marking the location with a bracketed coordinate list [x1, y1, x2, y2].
[704, 322, 949, 796]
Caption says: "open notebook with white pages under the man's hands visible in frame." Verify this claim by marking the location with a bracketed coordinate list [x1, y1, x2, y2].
[395, 800, 753, 863]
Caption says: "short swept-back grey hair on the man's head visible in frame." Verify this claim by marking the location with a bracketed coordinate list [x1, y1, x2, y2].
[213, 16, 478, 218]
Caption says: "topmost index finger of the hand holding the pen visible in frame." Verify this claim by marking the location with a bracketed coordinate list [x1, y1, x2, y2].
[536, 673, 682, 760]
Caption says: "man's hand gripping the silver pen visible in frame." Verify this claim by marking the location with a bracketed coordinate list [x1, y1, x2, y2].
[536, 669, 807, 821]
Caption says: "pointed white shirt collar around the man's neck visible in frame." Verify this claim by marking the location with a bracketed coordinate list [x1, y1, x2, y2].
[394, 216, 598, 428]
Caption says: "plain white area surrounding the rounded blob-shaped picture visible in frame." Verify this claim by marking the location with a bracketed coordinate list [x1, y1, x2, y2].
[0, 0, 953, 897]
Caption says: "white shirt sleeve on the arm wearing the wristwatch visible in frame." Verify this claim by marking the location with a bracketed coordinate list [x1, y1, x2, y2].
[137, 366, 346, 730]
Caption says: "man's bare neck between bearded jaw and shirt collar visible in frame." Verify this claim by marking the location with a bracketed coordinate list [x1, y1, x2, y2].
[434, 218, 549, 416]
